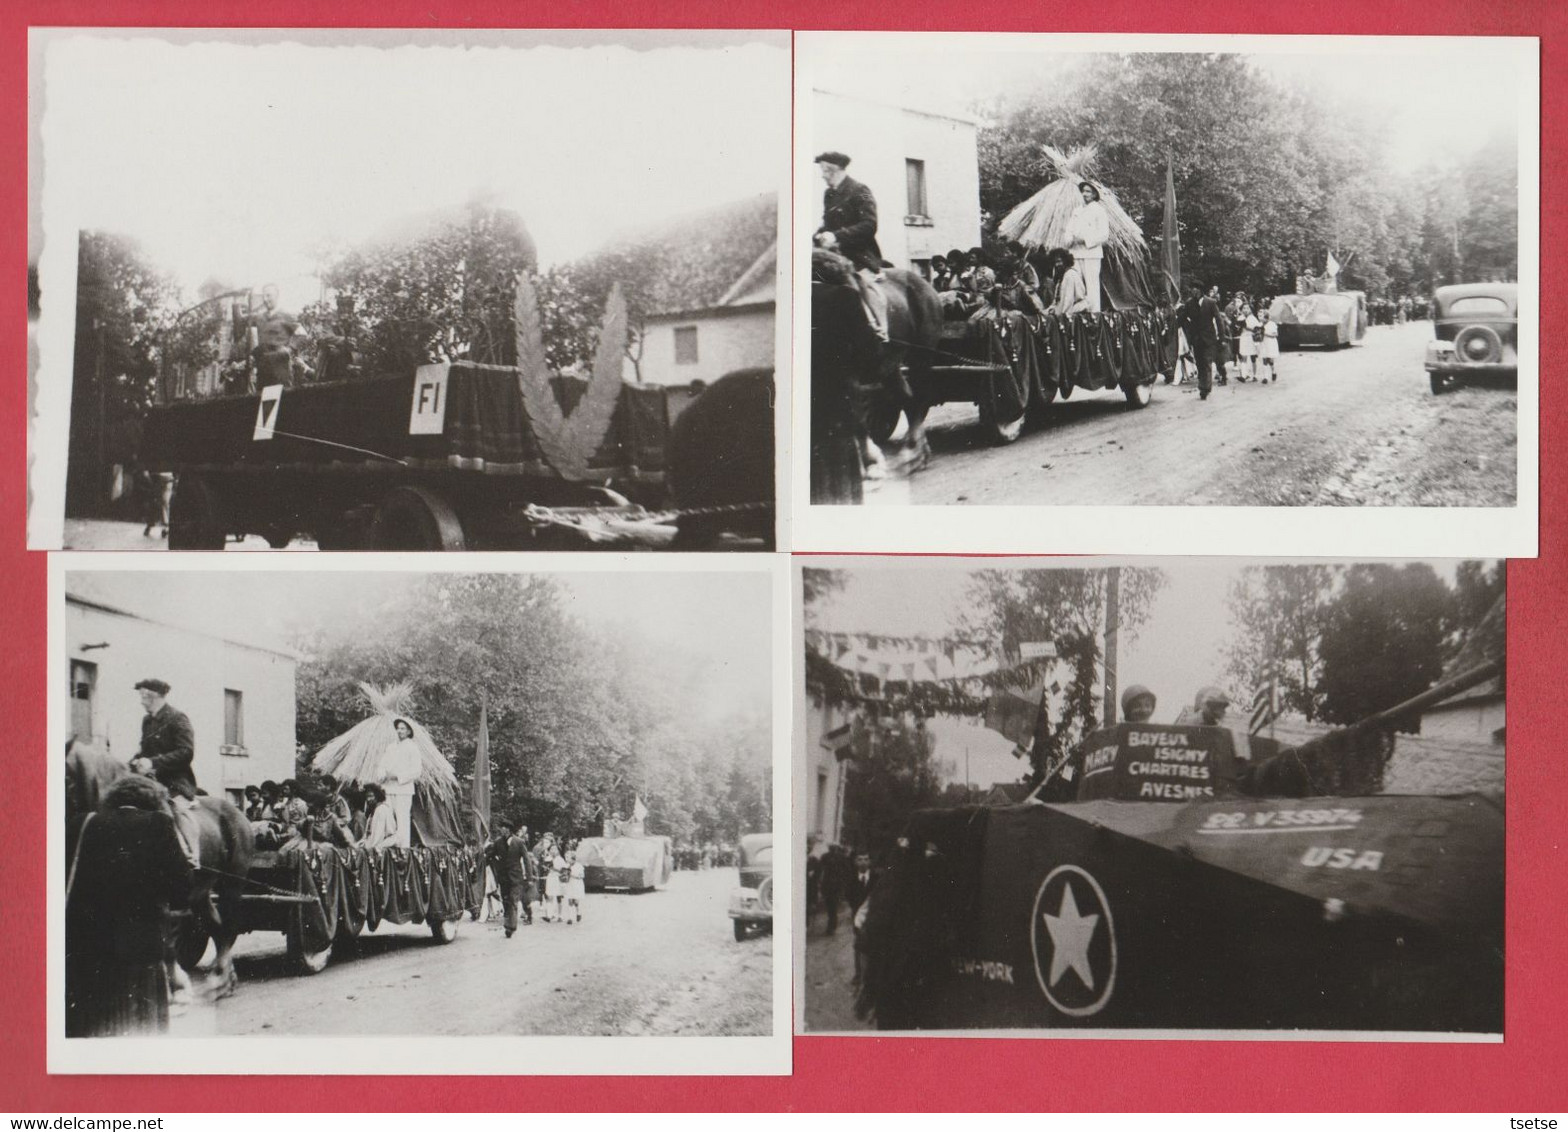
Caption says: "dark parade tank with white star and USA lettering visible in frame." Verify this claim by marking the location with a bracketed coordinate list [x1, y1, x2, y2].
[856, 663, 1504, 1033]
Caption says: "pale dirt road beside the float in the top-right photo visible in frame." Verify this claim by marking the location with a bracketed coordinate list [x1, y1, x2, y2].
[908, 323, 1518, 506]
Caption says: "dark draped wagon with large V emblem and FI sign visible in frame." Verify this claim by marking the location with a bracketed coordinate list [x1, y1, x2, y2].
[141, 278, 773, 550]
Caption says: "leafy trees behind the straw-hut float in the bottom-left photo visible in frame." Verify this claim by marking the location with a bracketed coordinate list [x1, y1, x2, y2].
[296, 574, 771, 842]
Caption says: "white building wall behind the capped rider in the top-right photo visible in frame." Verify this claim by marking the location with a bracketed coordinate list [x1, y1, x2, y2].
[806, 91, 980, 267]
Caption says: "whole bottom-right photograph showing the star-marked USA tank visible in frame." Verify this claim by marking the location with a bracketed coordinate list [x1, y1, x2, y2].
[795, 557, 1507, 1041]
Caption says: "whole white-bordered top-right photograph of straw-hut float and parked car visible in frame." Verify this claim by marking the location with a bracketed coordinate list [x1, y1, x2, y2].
[793, 33, 1538, 553]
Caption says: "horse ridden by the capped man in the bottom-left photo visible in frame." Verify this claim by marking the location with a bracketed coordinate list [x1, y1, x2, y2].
[66, 743, 256, 997]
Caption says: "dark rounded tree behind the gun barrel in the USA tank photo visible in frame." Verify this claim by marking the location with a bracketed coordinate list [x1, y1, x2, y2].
[1319, 563, 1452, 729]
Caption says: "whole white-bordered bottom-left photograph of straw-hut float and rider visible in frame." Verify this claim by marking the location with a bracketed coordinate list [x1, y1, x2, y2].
[50, 555, 789, 1072]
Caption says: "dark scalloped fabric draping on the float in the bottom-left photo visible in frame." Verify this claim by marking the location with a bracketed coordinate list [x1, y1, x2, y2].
[278, 845, 485, 952]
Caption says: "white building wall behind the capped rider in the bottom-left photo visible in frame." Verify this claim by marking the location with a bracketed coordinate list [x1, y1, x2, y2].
[58, 602, 295, 793]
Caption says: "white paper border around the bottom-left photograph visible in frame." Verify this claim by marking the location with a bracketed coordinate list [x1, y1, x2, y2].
[45, 552, 793, 1076]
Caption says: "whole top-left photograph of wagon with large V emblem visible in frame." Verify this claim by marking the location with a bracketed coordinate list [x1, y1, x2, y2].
[30, 30, 790, 550]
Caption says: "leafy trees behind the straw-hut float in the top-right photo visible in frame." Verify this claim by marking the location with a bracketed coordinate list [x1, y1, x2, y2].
[978, 53, 1518, 295]
